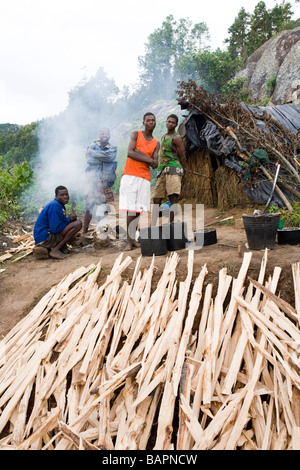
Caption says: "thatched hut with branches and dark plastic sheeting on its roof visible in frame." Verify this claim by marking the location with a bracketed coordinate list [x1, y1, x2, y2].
[179, 84, 300, 208]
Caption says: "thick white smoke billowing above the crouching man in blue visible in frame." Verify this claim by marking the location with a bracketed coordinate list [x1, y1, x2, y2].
[34, 69, 128, 205]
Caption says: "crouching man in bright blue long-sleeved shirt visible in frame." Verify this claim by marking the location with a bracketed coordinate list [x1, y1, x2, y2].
[33, 186, 82, 259]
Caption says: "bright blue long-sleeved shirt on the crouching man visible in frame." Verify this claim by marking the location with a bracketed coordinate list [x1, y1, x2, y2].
[33, 198, 71, 245]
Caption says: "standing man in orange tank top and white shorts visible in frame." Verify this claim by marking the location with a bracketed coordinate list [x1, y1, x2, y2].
[119, 113, 160, 251]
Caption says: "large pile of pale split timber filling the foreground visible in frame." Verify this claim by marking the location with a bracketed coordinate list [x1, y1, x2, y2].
[0, 251, 300, 450]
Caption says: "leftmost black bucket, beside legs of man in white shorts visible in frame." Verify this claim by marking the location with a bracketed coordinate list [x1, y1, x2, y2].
[140, 225, 168, 256]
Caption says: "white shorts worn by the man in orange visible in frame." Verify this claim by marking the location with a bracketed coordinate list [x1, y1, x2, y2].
[119, 175, 151, 212]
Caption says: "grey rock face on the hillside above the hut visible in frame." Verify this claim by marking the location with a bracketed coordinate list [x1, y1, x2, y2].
[236, 27, 300, 104]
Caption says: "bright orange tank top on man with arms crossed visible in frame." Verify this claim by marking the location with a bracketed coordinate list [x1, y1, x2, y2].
[123, 131, 157, 181]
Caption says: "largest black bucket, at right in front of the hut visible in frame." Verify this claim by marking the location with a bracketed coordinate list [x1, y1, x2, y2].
[243, 214, 281, 250]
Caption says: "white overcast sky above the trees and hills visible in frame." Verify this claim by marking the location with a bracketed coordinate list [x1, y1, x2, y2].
[0, 0, 300, 124]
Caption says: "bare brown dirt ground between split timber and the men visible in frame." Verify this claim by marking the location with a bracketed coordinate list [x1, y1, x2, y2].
[0, 204, 300, 340]
